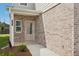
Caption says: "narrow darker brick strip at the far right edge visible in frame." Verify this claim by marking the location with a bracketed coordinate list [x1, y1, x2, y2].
[74, 3, 79, 56]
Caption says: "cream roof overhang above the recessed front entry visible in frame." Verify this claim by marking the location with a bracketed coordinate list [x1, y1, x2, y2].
[7, 7, 42, 16]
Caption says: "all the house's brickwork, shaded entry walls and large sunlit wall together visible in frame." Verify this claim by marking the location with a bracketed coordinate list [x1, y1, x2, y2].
[14, 3, 79, 55]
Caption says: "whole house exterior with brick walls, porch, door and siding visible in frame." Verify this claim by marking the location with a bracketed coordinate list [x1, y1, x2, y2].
[8, 3, 79, 55]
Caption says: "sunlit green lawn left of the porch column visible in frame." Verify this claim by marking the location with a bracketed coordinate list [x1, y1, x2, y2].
[0, 34, 9, 48]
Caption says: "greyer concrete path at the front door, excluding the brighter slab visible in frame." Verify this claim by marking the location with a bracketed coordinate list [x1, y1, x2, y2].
[26, 41, 45, 56]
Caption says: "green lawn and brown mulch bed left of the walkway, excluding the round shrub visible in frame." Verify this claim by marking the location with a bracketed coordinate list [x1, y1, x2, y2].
[0, 34, 32, 56]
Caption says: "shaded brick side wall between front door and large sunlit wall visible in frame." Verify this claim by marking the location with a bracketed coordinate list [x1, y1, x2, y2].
[35, 15, 46, 46]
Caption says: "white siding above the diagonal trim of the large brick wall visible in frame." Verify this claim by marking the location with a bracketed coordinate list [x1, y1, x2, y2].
[35, 3, 58, 12]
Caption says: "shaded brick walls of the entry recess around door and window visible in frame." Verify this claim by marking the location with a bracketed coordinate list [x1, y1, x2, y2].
[14, 14, 46, 46]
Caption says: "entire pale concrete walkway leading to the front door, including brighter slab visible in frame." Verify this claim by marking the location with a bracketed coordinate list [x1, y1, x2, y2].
[27, 41, 58, 56]
